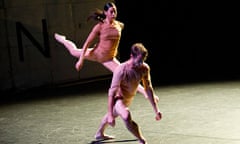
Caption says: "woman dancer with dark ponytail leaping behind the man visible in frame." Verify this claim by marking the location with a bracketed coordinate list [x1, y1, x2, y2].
[54, 2, 158, 100]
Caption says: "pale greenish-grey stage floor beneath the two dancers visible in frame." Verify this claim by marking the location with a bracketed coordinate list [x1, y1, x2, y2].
[0, 81, 240, 144]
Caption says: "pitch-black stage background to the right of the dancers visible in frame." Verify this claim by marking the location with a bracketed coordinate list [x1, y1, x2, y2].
[116, 0, 240, 84]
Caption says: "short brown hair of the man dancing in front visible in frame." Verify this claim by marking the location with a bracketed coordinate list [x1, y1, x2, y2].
[131, 43, 148, 61]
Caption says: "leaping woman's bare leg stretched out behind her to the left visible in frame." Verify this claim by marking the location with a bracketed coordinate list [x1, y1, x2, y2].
[54, 33, 82, 58]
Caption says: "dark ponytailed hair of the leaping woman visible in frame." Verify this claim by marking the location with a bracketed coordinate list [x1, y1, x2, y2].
[87, 2, 116, 22]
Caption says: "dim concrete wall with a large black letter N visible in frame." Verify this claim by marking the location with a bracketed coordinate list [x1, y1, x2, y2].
[0, 0, 114, 91]
